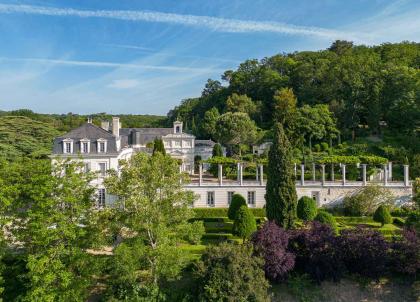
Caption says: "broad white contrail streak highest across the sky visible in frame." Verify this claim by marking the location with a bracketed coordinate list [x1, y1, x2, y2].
[0, 4, 357, 40]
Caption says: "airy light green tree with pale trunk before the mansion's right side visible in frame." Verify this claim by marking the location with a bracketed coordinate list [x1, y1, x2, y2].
[106, 152, 202, 300]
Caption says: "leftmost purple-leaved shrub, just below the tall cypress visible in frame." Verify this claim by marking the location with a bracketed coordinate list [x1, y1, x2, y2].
[251, 221, 295, 281]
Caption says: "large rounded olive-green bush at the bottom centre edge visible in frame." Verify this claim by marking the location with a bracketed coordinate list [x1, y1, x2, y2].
[194, 243, 269, 301]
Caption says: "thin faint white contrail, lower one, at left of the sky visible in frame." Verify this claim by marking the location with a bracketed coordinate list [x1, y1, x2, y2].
[0, 57, 223, 72]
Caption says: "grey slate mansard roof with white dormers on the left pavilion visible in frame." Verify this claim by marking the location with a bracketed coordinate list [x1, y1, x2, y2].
[52, 123, 117, 154]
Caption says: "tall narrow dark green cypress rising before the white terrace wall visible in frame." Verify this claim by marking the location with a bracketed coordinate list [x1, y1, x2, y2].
[265, 123, 297, 228]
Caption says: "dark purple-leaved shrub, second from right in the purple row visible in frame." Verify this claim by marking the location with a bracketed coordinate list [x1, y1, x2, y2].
[339, 227, 389, 278]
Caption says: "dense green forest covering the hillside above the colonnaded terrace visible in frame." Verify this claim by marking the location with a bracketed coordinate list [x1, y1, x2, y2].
[168, 41, 420, 176]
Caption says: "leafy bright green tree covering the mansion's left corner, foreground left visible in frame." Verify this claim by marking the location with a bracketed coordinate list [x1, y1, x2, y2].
[12, 161, 96, 301]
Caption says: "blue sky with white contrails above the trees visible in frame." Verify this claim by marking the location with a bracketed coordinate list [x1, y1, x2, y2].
[0, 0, 420, 114]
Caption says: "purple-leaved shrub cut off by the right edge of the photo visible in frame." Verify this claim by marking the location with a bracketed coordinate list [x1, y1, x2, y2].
[390, 229, 420, 275]
